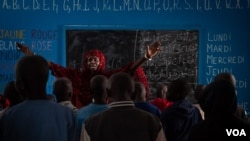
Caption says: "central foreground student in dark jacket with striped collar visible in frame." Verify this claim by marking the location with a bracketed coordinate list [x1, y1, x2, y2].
[81, 72, 166, 141]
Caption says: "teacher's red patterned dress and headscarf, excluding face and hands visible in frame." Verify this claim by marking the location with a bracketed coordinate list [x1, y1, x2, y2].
[50, 50, 149, 108]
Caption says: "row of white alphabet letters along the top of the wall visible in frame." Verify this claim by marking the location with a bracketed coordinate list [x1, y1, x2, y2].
[1, 0, 250, 13]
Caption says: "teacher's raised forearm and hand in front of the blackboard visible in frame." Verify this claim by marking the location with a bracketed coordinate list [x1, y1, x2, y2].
[128, 41, 161, 74]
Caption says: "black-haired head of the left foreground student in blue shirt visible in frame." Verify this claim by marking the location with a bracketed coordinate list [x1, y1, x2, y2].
[15, 55, 49, 99]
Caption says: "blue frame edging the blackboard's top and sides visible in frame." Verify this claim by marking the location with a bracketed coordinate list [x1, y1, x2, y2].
[62, 25, 204, 96]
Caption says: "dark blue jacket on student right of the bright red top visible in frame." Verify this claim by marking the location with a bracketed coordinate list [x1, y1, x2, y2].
[160, 100, 202, 141]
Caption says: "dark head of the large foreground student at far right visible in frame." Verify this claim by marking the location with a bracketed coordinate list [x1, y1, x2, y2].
[198, 79, 237, 116]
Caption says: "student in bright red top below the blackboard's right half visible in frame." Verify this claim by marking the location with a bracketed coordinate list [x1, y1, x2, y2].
[150, 83, 173, 112]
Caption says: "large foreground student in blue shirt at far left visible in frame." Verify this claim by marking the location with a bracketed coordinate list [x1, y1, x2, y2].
[0, 55, 76, 141]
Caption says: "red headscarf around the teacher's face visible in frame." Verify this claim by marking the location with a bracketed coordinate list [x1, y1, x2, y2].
[83, 49, 106, 71]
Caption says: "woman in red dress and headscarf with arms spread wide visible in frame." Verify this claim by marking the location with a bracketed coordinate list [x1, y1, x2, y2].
[17, 41, 161, 108]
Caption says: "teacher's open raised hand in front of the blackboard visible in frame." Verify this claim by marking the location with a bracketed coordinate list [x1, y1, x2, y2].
[145, 41, 161, 59]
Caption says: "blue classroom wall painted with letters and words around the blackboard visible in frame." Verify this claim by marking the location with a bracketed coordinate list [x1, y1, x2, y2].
[0, 0, 250, 112]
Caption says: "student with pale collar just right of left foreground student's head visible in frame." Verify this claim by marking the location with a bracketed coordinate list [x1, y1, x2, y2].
[53, 77, 78, 114]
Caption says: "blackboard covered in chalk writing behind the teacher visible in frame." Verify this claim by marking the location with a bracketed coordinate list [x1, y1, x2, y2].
[66, 29, 199, 97]
